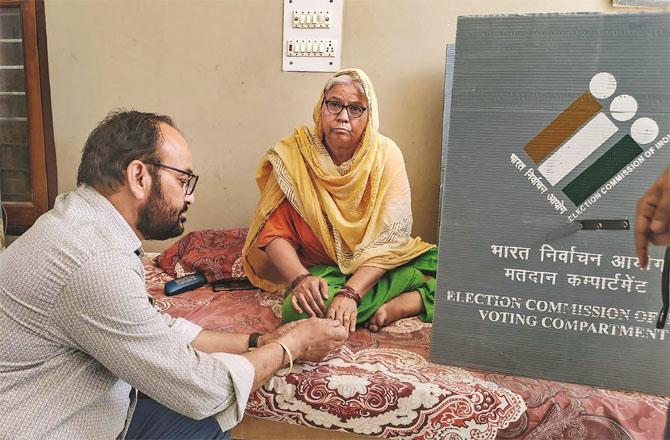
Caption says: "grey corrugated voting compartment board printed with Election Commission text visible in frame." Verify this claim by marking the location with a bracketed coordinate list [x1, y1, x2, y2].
[431, 13, 670, 395]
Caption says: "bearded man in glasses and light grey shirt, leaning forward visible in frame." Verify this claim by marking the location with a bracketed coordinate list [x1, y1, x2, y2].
[0, 111, 347, 439]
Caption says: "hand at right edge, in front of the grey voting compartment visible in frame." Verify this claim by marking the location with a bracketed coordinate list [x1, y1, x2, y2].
[635, 167, 670, 267]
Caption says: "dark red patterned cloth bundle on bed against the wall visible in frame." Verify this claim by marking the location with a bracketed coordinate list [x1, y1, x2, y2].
[156, 228, 247, 282]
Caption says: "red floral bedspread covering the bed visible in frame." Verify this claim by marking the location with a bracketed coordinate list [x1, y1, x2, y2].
[139, 254, 670, 440]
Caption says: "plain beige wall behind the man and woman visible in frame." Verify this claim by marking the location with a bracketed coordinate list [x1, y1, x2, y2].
[46, 0, 652, 250]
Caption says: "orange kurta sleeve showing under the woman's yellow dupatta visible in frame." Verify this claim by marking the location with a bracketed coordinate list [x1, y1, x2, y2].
[256, 200, 337, 267]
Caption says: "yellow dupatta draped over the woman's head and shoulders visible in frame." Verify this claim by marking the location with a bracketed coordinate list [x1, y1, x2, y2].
[243, 69, 433, 291]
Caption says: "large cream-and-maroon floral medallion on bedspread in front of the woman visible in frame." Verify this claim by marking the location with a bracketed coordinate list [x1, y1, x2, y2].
[247, 346, 526, 440]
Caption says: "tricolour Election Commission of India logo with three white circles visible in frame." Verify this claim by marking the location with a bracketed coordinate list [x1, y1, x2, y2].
[511, 72, 670, 217]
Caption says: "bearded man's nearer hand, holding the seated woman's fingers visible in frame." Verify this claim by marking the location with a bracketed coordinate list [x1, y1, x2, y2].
[282, 318, 349, 362]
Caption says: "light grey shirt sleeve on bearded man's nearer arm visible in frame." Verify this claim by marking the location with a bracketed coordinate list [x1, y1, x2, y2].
[53, 250, 254, 431]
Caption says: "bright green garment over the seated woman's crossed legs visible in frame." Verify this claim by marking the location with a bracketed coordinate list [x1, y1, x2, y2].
[282, 247, 437, 324]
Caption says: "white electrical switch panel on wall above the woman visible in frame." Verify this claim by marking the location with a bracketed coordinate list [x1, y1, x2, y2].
[282, 0, 344, 72]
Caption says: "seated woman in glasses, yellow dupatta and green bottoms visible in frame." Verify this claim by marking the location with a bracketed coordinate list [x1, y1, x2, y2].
[243, 69, 437, 332]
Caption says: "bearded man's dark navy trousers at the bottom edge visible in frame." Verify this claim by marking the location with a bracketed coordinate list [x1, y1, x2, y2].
[126, 399, 231, 440]
